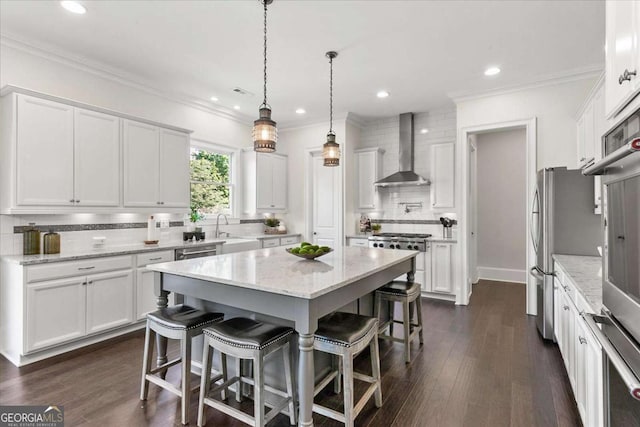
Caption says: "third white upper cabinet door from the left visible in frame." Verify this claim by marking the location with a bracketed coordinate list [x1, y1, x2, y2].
[123, 120, 160, 207]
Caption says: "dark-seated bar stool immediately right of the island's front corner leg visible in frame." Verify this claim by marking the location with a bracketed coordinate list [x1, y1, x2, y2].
[313, 312, 382, 427]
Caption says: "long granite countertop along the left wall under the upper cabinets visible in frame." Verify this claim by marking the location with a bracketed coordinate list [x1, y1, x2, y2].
[0, 238, 255, 265]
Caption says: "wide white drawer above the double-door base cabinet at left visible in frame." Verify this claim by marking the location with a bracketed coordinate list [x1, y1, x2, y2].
[26, 255, 133, 283]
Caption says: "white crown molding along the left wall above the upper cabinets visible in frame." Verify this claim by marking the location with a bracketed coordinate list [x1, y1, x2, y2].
[0, 32, 252, 126]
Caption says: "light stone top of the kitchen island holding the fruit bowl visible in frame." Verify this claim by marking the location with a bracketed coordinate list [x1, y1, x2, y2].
[147, 247, 419, 299]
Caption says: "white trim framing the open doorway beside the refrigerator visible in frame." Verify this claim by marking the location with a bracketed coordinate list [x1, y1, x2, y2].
[456, 117, 537, 315]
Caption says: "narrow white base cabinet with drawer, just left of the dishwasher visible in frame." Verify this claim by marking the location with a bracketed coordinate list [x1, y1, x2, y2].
[135, 251, 175, 320]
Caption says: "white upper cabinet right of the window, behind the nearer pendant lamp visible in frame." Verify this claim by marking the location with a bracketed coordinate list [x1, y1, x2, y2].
[242, 150, 288, 213]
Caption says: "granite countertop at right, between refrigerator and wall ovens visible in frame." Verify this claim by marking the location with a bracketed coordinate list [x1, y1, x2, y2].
[553, 254, 603, 314]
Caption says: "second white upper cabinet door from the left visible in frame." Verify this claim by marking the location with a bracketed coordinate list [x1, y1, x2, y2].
[74, 108, 121, 206]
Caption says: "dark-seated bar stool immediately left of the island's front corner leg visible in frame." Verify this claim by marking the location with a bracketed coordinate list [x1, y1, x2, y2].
[198, 317, 296, 427]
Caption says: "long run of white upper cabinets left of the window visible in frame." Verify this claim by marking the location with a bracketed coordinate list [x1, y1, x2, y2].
[0, 86, 190, 214]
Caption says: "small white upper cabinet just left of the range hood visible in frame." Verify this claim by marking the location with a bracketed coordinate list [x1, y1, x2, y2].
[354, 148, 384, 210]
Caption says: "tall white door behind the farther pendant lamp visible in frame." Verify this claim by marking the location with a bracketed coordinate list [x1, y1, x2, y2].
[305, 150, 344, 248]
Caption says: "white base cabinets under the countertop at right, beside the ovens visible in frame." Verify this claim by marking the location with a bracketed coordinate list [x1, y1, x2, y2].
[553, 264, 604, 427]
